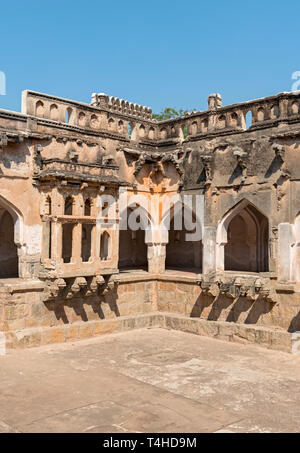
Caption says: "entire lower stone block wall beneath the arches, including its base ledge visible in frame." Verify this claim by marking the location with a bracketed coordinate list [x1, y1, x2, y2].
[0, 275, 300, 352]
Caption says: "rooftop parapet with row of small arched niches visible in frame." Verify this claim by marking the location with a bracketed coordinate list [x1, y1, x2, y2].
[15, 91, 300, 144]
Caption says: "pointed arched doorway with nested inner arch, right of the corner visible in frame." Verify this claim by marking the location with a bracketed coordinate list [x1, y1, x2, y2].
[224, 203, 269, 272]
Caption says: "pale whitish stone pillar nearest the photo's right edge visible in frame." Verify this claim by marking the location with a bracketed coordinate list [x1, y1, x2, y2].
[277, 223, 293, 282]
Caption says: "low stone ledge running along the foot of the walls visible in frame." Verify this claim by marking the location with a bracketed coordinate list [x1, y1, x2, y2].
[5, 312, 300, 354]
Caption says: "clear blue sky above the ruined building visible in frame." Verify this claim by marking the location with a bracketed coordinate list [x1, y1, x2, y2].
[0, 0, 300, 112]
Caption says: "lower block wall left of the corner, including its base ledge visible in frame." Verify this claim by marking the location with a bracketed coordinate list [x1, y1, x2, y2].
[0, 279, 155, 347]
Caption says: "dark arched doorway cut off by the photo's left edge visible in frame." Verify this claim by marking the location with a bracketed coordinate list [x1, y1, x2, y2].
[0, 207, 19, 278]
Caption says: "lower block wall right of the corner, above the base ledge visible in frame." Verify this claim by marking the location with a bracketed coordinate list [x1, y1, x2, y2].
[157, 279, 300, 332]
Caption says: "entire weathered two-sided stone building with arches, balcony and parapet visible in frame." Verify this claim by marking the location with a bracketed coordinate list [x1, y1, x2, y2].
[0, 86, 300, 351]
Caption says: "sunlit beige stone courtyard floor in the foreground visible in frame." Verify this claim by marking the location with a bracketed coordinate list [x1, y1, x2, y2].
[0, 329, 300, 433]
